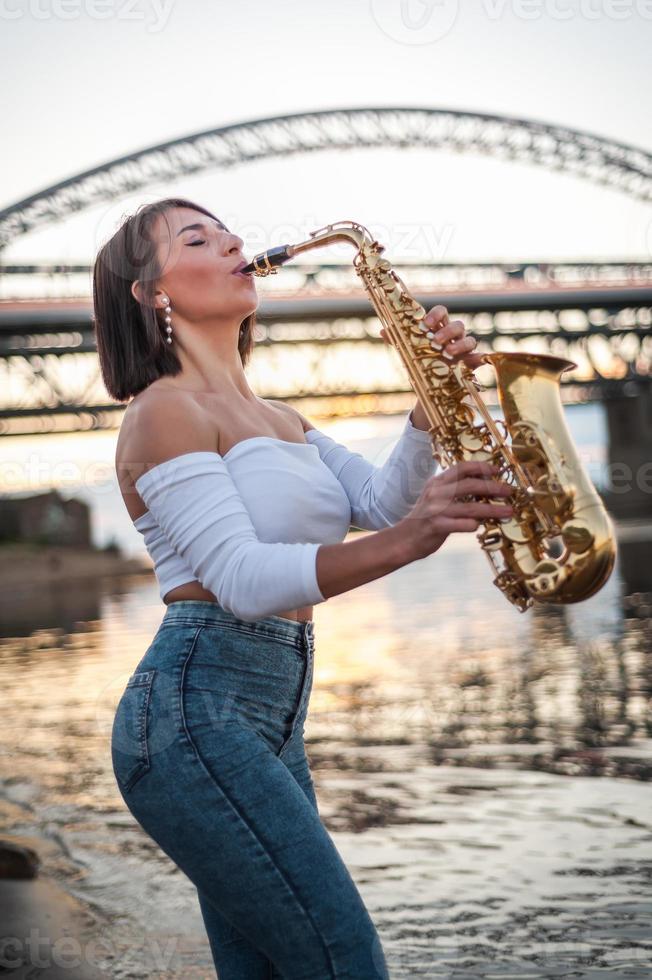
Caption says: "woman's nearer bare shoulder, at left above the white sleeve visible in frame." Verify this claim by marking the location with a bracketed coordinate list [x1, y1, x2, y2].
[115, 388, 218, 484]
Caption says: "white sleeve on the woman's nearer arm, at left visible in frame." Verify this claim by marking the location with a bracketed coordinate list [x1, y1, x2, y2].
[134, 452, 326, 621]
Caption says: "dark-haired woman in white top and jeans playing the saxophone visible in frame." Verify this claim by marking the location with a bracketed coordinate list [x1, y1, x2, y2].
[93, 198, 511, 980]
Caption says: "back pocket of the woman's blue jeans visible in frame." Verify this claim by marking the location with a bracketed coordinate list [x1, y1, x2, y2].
[111, 670, 156, 793]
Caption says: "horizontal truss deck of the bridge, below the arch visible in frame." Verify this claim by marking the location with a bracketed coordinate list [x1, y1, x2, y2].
[0, 266, 652, 434]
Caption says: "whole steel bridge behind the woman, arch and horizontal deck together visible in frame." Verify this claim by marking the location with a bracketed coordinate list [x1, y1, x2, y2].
[0, 107, 652, 516]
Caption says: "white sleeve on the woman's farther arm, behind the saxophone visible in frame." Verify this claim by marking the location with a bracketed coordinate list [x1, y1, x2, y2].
[306, 416, 438, 531]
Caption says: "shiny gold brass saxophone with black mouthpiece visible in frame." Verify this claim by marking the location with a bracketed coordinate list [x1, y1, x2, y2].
[242, 221, 616, 612]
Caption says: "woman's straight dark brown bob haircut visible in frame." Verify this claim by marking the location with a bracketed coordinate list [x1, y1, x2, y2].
[93, 197, 256, 402]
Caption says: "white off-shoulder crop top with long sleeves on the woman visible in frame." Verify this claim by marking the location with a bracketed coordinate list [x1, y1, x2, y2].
[133, 417, 437, 621]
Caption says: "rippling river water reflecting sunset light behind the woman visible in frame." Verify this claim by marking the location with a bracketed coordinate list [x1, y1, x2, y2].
[0, 406, 652, 980]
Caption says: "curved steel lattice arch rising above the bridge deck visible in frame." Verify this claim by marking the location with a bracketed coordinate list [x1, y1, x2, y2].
[0, 106, 652, 250]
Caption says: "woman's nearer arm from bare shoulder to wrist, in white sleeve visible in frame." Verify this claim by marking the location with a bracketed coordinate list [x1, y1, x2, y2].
[126, 393, 423, 621]
